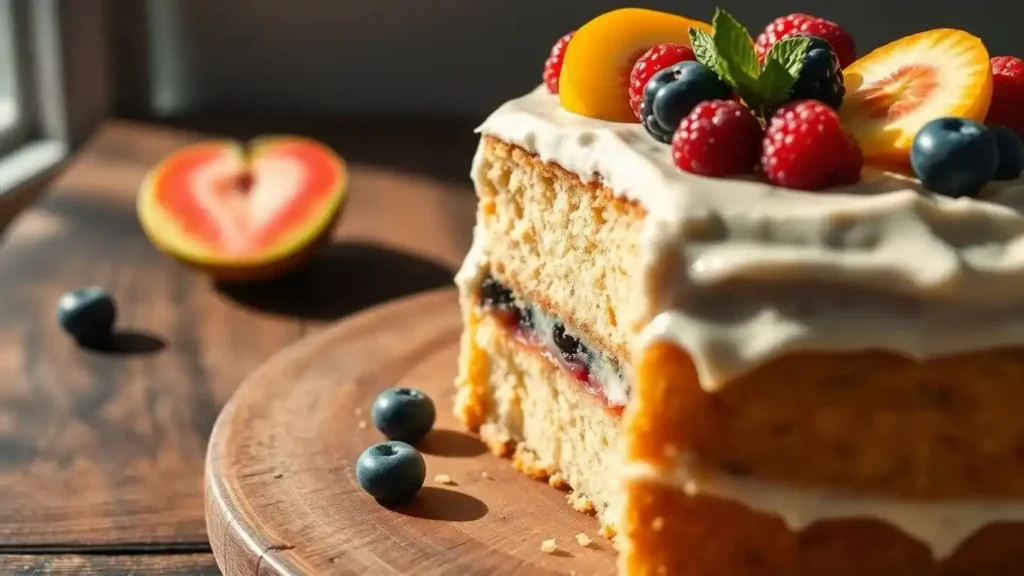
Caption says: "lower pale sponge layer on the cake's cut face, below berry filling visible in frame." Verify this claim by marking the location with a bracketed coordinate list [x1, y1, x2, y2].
[457, 307, 621, 524]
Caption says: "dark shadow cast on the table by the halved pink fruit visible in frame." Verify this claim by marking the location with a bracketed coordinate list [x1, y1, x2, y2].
[216, 242, 454, 321]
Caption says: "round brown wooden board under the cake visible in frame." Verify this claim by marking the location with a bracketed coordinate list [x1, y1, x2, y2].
[206, 289, 614, 576]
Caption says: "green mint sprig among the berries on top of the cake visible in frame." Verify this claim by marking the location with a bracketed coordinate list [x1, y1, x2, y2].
[690, 9, 810, 116]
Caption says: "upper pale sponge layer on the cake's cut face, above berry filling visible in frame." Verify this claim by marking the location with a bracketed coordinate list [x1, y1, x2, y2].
[474, 134, 643, 360]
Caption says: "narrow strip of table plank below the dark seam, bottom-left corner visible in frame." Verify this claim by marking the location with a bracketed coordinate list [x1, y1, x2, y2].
[0, 553, 221, 576]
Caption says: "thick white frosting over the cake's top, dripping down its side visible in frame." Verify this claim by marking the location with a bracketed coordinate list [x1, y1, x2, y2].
[473, 87, 1024, 390]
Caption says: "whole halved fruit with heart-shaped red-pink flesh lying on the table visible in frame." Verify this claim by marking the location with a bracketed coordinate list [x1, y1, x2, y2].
[137, 136, 347, 280]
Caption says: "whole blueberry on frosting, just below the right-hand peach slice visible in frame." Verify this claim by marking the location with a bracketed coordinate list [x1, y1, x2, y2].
[910, 118, 999, 198]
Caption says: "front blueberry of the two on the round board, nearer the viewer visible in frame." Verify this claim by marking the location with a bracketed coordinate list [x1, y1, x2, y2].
[355, 442, 427, 502]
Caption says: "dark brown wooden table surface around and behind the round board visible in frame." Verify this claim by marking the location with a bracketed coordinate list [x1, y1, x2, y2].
[0, 122, 474, 575]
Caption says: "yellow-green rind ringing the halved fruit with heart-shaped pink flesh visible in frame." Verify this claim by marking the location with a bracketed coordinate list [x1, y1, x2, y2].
[136, 135, 348, 278]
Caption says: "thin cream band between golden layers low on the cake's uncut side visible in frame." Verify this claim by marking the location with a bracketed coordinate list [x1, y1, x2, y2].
[623, 463, 1024, 560]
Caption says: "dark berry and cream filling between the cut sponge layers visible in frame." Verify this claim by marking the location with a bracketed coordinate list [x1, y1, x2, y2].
[479, 276, 630, 413]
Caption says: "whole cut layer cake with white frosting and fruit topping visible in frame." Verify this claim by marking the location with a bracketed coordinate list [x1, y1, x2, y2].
[455, 8, 1024, 576]
